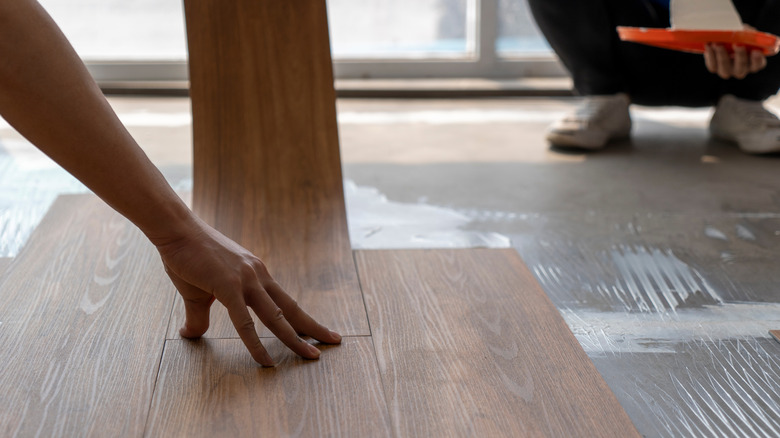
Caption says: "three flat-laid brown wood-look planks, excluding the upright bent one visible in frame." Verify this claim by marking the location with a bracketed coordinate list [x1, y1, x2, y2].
[0, 195, 636, 437]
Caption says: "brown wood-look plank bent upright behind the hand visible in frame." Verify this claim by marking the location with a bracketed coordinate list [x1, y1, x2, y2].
[184, 0, 368, 337]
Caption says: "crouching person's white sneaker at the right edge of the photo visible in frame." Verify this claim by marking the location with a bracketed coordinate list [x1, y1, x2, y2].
[710, 94, 780, 154]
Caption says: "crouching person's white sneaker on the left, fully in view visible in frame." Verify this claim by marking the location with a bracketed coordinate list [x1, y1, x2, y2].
[547, 93, 631, 150]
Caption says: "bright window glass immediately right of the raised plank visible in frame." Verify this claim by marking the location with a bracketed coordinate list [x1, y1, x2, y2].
[328, 0, 476, 59]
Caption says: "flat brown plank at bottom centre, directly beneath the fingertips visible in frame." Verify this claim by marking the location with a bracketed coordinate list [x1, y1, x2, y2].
[147, 337, 391, 437]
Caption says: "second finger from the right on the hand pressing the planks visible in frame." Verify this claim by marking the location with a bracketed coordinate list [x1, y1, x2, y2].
[246, 288, 320, 359]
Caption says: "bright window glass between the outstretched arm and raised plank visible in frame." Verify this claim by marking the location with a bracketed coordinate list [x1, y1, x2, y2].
[39, 0, 187, 61]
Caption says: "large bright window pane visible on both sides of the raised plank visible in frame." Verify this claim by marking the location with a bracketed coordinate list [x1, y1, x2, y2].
[40, 0, 476, 61]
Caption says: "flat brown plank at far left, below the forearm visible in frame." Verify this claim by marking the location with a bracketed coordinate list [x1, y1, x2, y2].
[0, 195, 174, 437]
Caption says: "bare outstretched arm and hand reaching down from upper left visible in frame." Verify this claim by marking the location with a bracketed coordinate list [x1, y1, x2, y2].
[0, 0, 341, 365]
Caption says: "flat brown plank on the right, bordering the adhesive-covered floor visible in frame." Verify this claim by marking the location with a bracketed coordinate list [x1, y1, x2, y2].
[357, 250, 638, 437]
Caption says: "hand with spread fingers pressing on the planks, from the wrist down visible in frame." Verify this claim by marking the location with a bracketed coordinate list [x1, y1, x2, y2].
[155, 218, 341, 366]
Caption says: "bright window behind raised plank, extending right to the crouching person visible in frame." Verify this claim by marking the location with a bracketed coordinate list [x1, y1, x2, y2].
[40, 0, 563, 81]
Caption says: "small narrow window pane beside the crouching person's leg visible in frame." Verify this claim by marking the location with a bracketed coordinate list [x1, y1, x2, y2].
[496, 0, 551, 57]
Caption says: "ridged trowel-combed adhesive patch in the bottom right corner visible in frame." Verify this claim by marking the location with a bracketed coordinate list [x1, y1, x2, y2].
[608, 337, 780, 437]
